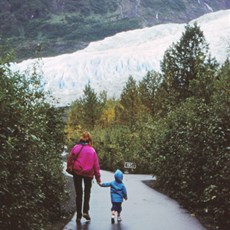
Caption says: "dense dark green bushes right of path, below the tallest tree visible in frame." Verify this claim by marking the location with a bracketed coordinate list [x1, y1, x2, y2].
[153, 62, 230, 229]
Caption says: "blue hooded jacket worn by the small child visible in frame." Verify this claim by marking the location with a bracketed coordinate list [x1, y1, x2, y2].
[101, 170, 127, 202]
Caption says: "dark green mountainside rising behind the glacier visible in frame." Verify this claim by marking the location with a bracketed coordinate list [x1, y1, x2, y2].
[0, 0, 230, 60]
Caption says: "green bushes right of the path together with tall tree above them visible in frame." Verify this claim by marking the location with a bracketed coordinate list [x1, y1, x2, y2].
[148, 24, 230, 229]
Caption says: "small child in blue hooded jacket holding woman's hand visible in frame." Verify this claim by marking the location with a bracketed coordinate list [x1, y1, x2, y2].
[99, 169, 128, 224]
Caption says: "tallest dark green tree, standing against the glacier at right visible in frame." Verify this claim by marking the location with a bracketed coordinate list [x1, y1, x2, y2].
[161, 23, 216, 105]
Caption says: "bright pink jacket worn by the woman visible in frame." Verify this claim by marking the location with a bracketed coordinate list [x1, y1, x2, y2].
[71, 144, 101, 182]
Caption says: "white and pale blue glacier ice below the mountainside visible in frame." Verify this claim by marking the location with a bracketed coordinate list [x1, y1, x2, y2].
[14, 10, 230, 105]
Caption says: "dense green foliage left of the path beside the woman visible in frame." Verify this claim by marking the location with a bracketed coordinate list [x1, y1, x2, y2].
[0, 48, 64, 229]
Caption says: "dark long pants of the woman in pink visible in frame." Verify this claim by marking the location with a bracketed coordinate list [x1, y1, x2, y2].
[73, 174, 92, 218]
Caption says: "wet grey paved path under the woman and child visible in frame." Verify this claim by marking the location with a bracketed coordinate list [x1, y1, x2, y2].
[63, 171, 205, 230]
